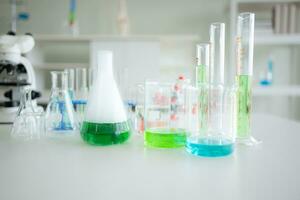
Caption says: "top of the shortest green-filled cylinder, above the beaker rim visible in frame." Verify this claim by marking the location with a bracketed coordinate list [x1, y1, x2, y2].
[196, 43, 210, 87]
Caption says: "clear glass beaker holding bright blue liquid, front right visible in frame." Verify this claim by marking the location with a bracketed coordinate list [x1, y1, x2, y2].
[186, 85, 236, 157]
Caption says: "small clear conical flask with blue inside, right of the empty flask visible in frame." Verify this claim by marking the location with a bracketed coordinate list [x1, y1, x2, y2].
[46, 71, 78, 131]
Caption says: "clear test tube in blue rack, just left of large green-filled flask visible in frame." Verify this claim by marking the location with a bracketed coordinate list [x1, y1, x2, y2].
[73, 68, 88, 125]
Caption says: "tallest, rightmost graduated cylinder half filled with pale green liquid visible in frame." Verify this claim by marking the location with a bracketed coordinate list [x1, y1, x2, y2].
[236, 13, 259, 145]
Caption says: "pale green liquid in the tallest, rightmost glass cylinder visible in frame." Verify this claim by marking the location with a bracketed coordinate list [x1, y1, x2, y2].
[237, 75, 252, 138]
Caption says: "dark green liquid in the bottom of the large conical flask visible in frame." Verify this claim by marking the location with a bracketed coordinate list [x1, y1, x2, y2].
[80, 121, 130, 146]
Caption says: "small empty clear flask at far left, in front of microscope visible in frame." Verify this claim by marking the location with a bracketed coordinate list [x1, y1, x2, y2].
[11, 88, 45, 140]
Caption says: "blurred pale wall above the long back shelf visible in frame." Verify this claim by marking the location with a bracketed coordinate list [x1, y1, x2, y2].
[0, 0, 229, 35]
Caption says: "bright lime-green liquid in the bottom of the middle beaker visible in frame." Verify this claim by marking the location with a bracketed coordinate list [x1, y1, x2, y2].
[145, 129, 186, 148]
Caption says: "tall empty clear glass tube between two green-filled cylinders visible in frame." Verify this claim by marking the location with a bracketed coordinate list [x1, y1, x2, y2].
[208, 22, 225, 130]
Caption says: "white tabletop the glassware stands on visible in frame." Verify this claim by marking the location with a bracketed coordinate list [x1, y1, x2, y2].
[0, 115, 300, 200]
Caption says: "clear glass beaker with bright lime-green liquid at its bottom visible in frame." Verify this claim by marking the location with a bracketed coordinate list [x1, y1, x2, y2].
[144, 81, 186, 148]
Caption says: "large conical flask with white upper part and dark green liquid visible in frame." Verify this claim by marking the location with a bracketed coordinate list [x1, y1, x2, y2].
[80, 51, 130, 145]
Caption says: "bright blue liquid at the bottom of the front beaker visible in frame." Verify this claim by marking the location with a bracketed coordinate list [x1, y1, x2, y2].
[186, 138, 234, 157]
